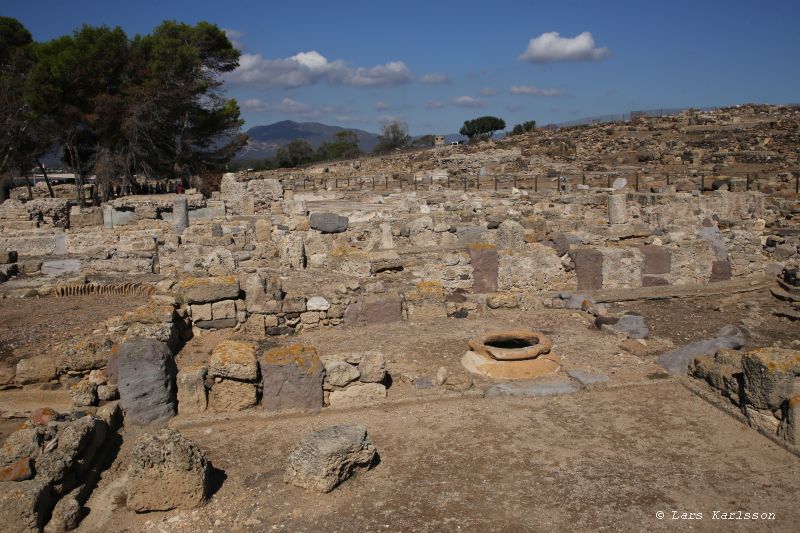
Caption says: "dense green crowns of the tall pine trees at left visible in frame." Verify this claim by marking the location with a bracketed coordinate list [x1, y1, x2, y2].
[0, 18, 247, 200]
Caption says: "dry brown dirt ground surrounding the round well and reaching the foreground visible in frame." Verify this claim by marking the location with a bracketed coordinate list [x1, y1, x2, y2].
[0, 288, 800, 531]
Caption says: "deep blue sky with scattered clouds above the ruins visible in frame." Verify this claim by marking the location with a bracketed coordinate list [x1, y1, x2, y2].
[6, 0, 800, 135]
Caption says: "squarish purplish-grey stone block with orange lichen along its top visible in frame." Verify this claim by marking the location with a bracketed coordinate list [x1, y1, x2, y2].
[260, 344, 325, 411]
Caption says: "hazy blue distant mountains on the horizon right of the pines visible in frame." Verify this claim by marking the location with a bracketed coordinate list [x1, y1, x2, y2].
[236, 120, 466, 161]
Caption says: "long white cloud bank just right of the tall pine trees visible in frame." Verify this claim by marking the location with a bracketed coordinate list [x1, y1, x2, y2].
[227, 50, 413, 88]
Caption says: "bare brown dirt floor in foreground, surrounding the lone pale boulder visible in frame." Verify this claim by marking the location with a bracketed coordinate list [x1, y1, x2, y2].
[94, 380, 800, 532]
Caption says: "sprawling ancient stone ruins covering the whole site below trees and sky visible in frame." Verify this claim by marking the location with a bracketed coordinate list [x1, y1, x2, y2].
[0, 105, 800, 531]
